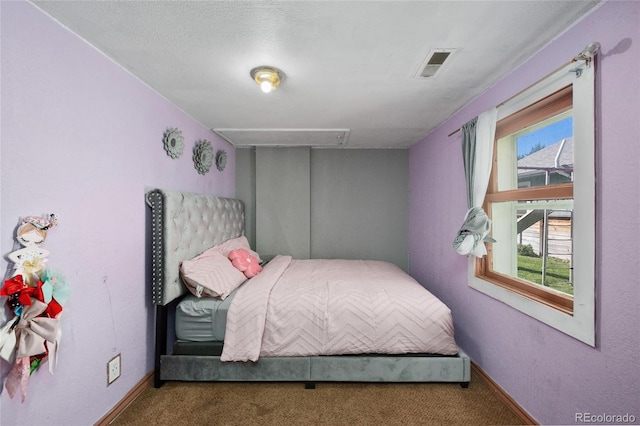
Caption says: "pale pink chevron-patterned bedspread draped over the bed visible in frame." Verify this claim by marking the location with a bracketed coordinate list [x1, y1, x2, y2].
[221, 256, 458, 361]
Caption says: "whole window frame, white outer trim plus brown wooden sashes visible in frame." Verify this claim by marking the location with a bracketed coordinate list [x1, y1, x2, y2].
[468, 61, 596, 346]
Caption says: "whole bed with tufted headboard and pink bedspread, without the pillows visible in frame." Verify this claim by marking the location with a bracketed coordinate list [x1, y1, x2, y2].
[146, 189, 470, 388]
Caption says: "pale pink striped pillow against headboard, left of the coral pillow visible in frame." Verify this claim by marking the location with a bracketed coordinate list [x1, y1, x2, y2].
[180, 253, 247, 300]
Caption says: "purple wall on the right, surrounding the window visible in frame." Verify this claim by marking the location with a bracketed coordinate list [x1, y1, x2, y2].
[409, 1, 640, 424]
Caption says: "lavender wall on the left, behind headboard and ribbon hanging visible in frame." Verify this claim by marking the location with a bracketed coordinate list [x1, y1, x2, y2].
[0, 2, 235, 425]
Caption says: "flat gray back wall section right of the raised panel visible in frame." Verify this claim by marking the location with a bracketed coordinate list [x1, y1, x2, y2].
[311, 149, 409, 270]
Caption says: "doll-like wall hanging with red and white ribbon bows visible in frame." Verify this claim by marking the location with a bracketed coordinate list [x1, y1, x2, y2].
[0, 214, 71, 402]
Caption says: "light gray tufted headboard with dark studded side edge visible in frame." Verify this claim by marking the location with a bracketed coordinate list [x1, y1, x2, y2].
[146, 189, 244, 305]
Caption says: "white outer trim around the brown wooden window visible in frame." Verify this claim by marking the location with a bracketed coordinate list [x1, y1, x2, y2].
[468, 62, 596, 346]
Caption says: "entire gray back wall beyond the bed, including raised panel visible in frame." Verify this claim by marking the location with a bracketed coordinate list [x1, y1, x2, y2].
[236, 148, 409, 271]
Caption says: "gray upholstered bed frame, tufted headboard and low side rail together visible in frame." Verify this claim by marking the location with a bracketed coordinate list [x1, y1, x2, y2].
[146, 189, 471, 388]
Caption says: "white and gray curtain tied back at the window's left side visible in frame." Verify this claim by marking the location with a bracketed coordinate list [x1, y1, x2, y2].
[453, 108, 498, 257]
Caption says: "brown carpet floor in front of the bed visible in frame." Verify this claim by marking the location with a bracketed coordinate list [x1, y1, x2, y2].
[112, 378, 522, 426]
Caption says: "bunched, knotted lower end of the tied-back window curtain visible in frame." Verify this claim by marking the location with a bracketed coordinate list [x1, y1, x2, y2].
[453, 207, 496, 257]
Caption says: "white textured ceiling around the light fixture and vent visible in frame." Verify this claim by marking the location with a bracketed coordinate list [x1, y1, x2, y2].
[33, 0, 599, 148]
